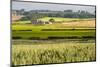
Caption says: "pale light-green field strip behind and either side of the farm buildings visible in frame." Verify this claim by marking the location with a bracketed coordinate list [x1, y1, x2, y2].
[13, 17, 94, 24]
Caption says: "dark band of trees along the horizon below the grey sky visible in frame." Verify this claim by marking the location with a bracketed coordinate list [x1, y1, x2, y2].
[18, 10, 95, 20]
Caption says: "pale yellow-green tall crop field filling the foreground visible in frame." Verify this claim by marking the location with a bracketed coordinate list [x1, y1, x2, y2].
[12, 43, 96, 65]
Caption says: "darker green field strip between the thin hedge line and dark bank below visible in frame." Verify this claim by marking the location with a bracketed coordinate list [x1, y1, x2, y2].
[12, 30, 95, 39]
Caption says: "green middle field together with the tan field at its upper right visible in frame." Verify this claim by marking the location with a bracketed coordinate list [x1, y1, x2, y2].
[12, 20, 95, 39]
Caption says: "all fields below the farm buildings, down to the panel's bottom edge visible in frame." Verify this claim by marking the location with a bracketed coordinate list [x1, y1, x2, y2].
[12, 18, 96, 65]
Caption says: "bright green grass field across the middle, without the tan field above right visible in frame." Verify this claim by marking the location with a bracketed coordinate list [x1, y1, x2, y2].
[12, 24, 95, 39]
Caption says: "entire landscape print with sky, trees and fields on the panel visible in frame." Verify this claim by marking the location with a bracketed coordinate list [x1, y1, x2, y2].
[11, 1, 96, 67]
